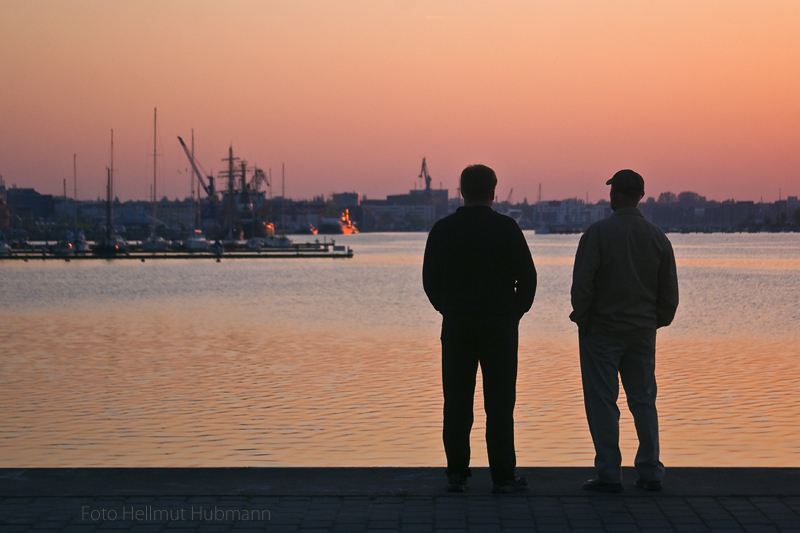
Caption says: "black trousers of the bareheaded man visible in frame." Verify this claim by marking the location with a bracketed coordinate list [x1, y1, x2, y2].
[441, 316, 519, 483]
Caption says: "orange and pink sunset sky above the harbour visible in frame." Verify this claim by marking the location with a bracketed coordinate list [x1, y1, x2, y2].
[0, 0, 800, 202]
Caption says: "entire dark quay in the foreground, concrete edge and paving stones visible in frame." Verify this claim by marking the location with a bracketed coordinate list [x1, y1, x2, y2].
[0, 468, 800, 533]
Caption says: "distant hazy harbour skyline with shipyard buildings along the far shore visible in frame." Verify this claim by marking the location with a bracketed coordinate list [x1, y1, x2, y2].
[0, 170, 800, 240]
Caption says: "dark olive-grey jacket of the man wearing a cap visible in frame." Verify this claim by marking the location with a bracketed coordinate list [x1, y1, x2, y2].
[569, 207, 678, 338]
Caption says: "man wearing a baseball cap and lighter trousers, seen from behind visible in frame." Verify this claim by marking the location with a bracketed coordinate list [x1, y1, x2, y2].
[570, 170, 678, 492]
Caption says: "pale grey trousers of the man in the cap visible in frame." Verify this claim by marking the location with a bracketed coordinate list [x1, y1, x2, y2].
[580, 332, 664, 483]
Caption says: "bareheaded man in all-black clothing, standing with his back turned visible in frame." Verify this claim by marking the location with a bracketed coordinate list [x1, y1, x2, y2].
[422, 165, 536, 493]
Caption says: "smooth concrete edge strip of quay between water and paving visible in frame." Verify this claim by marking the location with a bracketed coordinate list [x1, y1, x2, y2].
[0, 467, 800, 497]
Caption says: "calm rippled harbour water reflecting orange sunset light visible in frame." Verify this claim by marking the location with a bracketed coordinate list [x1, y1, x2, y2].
[0, 233, 800, 467]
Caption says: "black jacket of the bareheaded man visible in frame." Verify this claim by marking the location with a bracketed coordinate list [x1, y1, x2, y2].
[422, 206, 536, 319]
